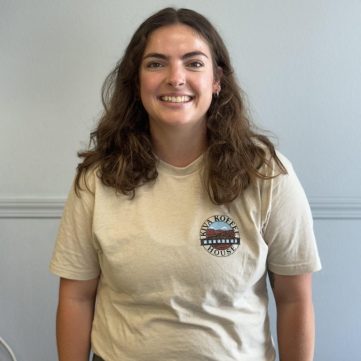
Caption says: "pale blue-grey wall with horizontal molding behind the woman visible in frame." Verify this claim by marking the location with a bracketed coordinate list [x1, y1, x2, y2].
[0, 0, 361, 361]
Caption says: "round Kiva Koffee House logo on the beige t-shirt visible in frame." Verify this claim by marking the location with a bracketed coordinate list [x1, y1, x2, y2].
[200, 215, 240, 257]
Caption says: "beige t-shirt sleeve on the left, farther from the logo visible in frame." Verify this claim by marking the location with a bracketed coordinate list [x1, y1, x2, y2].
[50, 171, 99, 280]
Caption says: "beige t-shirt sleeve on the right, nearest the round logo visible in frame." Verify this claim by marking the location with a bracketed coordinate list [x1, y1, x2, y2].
[263, 156, 321, 275]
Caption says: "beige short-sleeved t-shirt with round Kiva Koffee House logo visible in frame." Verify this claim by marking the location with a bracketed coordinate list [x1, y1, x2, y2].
[50, 155, 320, 361]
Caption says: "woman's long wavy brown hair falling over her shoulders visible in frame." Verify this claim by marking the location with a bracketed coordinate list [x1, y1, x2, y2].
[75, 8, 286, 204]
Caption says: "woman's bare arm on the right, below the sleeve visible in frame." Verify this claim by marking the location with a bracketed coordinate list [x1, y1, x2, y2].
[270, 273, 315, 361]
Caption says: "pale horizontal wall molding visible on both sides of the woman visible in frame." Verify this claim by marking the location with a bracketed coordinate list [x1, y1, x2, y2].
[0, 197, 361, 220]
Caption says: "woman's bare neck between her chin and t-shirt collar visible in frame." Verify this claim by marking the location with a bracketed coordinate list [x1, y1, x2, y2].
[151, 121, 207, 167]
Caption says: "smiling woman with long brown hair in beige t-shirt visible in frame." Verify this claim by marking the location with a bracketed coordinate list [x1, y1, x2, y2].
[51, 8, 320, 361]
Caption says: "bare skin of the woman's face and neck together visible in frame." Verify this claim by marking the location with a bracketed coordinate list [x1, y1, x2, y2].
[140, 24, 219, 166]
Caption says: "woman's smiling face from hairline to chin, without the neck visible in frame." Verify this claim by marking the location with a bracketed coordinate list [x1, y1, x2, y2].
[139, 24, 218, 129]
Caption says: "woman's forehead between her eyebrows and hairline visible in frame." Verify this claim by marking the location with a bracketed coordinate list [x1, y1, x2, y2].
[144, 24, 211, 56]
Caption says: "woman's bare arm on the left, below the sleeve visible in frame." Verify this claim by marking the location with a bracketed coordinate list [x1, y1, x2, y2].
[56, 278, 98, 361]
